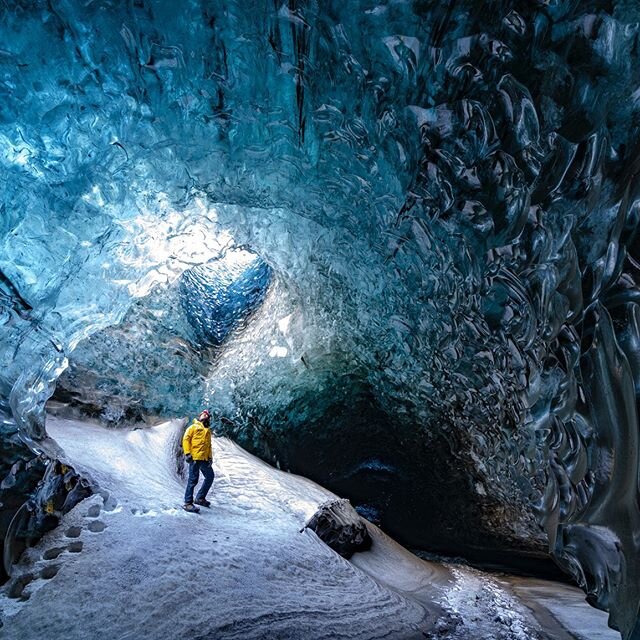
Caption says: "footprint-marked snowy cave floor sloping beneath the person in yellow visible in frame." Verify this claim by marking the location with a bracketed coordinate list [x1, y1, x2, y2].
[0, 417, 620, 640]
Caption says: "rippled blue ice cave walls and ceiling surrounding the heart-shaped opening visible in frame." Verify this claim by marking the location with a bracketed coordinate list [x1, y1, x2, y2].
[0, 0, 640, 638]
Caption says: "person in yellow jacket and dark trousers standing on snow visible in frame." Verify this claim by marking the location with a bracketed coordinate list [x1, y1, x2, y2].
[182, 409, 215, 513]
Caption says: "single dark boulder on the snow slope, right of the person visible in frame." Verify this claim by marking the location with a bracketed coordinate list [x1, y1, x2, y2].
[302, 499, 371, 558]
